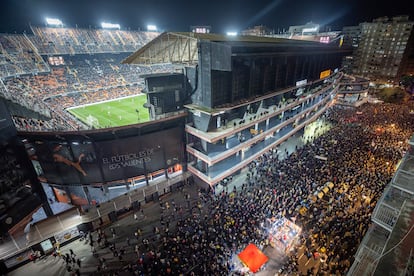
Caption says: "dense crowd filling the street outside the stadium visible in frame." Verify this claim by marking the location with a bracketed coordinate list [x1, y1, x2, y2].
[57, 104, 414, 275]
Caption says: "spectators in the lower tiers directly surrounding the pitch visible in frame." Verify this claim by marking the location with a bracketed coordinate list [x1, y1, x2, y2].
[0, 50, 178, 131]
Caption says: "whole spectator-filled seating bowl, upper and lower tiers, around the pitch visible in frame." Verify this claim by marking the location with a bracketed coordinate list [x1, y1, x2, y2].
[0, 26, 183, 131]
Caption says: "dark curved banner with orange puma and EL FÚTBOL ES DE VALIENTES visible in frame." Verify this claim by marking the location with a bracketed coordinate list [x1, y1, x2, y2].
[28, 128, 183, 184]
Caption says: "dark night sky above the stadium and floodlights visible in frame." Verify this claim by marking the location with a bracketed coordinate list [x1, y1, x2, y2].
[0, 0, 414, 33]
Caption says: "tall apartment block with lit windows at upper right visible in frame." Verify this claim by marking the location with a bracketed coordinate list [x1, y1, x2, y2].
[353, 16, 414, 80]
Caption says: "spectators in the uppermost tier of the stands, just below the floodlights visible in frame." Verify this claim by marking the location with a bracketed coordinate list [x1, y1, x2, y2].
[0, 27, 159, 78]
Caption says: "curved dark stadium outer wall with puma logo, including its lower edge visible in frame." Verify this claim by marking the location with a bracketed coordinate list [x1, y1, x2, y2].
[18, 113, 186, 205]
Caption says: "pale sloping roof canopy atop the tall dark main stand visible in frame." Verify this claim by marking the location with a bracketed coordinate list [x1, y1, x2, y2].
[122, 32, 346, 65]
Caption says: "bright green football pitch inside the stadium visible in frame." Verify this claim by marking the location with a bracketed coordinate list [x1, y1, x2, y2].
[67, 95, 149, 128]
